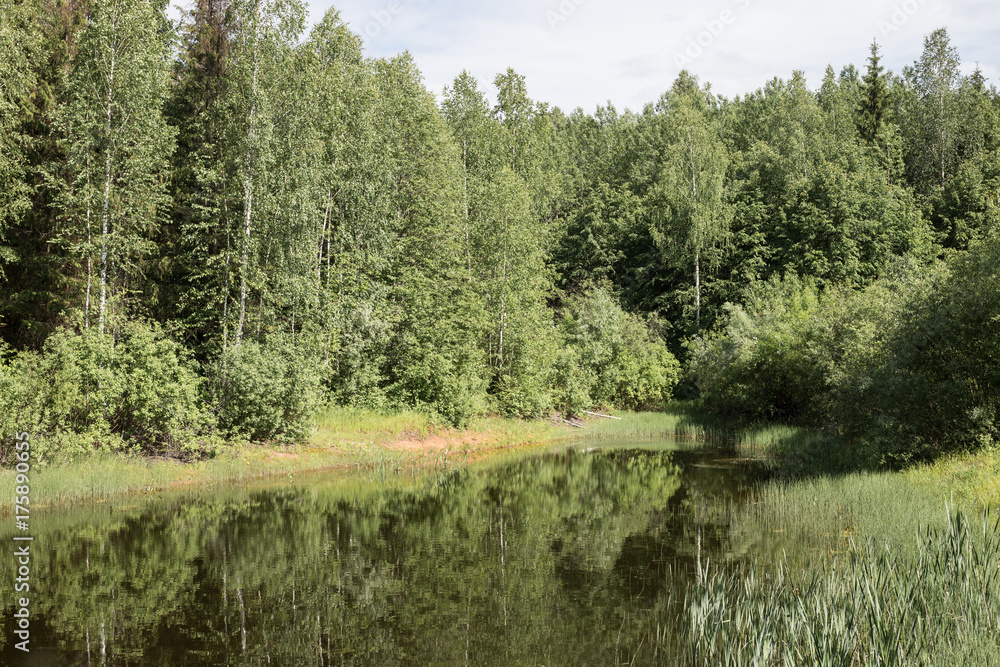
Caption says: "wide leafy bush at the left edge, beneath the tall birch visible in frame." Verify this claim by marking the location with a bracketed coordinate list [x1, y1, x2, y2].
[0, 322, 214, 460]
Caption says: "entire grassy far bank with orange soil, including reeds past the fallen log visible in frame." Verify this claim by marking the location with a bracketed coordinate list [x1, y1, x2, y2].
[0, 404, 722, 516]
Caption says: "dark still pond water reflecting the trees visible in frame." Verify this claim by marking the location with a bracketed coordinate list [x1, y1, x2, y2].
[0, 443, 760, 666]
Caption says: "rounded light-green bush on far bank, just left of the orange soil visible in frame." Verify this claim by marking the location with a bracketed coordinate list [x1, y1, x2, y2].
[210, 335, 323, 442]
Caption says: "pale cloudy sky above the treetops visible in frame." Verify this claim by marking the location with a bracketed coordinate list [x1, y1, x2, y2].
[205, 0, 1000, 113]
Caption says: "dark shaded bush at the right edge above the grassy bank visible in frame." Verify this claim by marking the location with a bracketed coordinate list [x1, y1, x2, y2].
[838, 237, 1000, 462]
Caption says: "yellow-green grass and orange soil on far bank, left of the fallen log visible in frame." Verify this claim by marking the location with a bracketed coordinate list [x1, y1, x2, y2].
[0, 408, 578, 516]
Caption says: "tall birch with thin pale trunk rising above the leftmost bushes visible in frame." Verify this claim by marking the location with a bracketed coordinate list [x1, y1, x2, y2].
[59, 0, 174, 333]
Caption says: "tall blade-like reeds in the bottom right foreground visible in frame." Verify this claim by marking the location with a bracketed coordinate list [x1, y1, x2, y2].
[656, 512, 1000, 665]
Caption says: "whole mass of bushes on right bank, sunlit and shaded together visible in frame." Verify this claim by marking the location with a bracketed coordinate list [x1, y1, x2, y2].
[690, 238, 1000, 464]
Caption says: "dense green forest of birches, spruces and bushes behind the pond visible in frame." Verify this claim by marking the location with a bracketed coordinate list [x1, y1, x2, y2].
[0, 0, 1000, 465]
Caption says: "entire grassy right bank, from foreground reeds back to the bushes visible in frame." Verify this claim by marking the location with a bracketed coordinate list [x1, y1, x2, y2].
[655, 418, 1000, 665]
